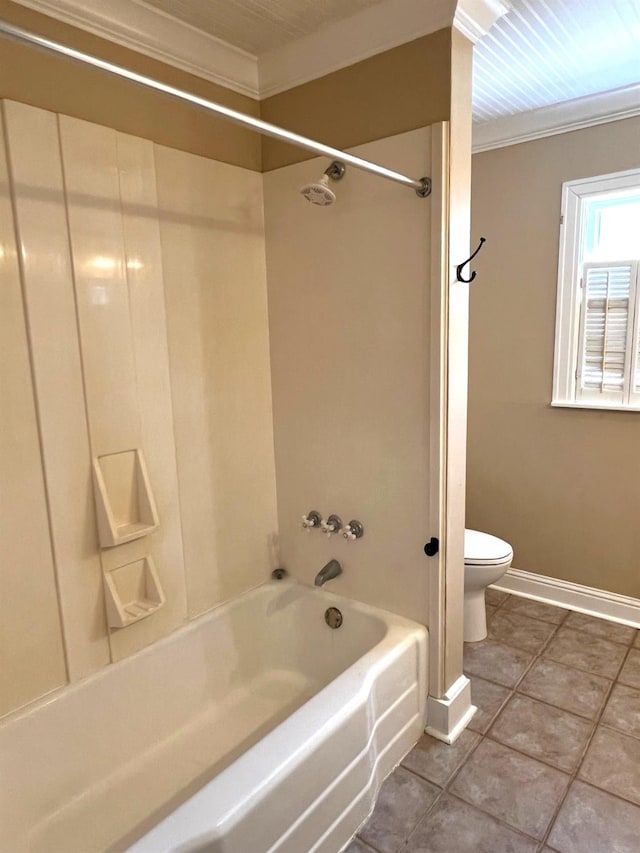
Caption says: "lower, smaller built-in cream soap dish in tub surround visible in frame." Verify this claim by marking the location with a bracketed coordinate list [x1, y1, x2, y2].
[104, 557, 165, 628]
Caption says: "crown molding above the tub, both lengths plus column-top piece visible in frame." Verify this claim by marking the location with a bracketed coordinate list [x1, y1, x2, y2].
[11, 0, 508, 98]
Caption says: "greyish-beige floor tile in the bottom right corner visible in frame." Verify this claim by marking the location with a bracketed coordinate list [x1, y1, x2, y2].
[549, 781, 640, 853]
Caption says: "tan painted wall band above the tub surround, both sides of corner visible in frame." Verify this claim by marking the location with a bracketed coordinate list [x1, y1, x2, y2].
[0, 0, 451, 171]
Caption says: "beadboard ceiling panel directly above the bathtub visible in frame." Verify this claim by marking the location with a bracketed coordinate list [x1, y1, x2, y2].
[136, 0, 390, 56]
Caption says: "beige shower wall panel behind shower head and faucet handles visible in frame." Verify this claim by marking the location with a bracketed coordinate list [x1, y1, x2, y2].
[265, 128, 431, 622]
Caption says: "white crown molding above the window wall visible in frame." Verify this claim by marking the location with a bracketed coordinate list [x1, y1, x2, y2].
[473, 83, 640, 154]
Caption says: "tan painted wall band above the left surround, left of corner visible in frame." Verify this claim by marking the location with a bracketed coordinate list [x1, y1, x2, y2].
[0, 0, 261, 171]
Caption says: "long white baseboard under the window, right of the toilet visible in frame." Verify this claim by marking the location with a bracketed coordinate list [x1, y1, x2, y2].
[492, 569, 640, 628]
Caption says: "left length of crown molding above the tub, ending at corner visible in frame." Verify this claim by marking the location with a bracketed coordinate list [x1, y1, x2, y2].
[10, 0, 260, 98]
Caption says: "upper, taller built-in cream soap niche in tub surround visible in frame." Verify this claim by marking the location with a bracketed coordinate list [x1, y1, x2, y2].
[93, 449, 158, 548]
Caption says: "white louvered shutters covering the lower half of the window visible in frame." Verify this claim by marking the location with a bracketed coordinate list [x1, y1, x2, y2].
[576, 261, 640, 405]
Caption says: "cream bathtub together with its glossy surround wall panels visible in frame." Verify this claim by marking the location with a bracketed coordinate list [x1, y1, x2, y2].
[0, 95, 450, 853]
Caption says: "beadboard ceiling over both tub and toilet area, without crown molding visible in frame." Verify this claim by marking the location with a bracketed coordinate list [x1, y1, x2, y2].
[139, 0, 640, 123]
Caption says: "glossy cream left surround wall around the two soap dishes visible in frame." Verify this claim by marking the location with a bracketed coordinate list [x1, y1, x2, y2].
[0, 101, 276, 714]
